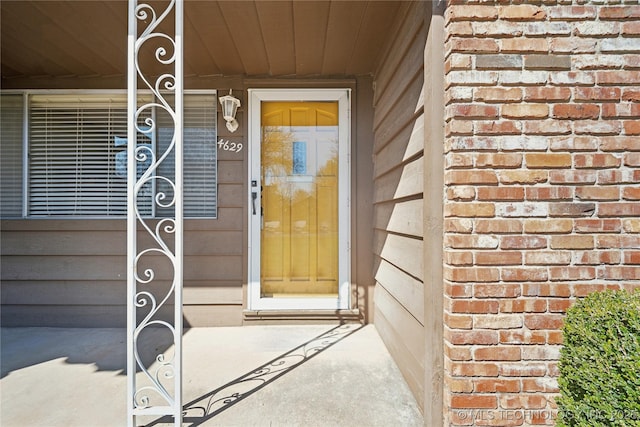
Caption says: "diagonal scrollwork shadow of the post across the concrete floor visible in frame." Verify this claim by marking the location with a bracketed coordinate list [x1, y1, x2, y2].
[147, 324, 364, 427]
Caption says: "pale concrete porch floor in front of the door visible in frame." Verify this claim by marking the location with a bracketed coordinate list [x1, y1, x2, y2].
[0, 325, 423, 427]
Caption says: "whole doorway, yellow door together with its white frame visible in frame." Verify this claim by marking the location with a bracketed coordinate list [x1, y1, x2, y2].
[248, 89, 350, 310]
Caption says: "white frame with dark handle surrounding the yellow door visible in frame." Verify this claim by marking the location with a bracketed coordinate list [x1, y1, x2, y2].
[247, 89, 351, 310]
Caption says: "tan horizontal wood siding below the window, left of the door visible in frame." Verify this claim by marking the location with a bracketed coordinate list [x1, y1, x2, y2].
[1, 217, 243, 327]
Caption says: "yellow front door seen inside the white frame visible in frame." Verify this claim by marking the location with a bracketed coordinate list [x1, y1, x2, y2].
[260, 101, 339, 298]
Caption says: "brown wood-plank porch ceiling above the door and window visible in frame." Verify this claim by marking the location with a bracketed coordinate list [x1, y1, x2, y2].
[0, 0, 402, 82]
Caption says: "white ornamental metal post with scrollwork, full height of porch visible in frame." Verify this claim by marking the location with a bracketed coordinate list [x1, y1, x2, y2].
[127, 0, 184, 426]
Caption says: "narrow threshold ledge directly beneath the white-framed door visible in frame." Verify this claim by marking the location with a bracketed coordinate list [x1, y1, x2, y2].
[242, 309, 364, 324]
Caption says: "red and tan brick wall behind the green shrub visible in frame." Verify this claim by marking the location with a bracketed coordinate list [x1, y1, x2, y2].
[444, 0, 640, 426]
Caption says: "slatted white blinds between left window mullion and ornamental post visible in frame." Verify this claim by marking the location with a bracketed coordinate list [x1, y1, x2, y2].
[28, 95, 127, 216]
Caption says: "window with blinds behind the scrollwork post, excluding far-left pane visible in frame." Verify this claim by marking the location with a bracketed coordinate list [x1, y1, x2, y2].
[28, 93, 217, 218]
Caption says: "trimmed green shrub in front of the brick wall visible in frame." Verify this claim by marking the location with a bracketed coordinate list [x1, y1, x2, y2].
[556, 291, 640, 427]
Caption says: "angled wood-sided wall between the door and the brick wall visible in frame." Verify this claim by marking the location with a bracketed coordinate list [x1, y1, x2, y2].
[373, 2, 427, 414]
